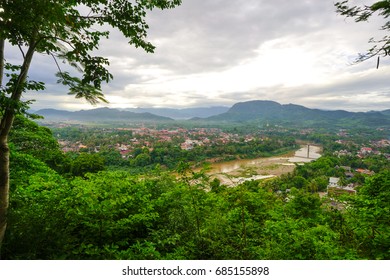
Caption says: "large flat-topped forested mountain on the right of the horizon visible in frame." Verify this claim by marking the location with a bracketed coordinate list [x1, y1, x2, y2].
[205, 100, 390, 126]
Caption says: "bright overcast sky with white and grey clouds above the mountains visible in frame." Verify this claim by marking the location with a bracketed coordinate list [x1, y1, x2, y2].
[6, 0, 390, 112]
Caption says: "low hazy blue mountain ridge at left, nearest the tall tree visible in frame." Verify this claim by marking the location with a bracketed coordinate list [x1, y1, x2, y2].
[34, 108, 173, 123]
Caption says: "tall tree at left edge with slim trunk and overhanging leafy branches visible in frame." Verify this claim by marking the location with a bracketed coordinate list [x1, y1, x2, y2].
[0, 0, 181, 254]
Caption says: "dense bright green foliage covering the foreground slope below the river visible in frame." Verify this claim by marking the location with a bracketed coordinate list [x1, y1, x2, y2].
[2, 117, 390, 260]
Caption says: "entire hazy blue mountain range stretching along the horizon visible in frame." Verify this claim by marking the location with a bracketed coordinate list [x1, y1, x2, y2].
[35, 100, 390, 126]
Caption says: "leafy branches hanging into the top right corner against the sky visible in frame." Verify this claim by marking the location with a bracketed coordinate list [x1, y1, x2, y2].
[335, 0, 390, 67]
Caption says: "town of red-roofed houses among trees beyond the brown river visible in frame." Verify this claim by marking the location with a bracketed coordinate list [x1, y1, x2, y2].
[47, 124, 390, 193]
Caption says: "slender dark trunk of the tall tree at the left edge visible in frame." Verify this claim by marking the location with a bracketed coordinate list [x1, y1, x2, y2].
[0, 38, 36, 253]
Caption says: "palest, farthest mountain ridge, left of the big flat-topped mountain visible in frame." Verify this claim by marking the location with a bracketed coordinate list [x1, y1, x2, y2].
[124, 106, 229, 120]
